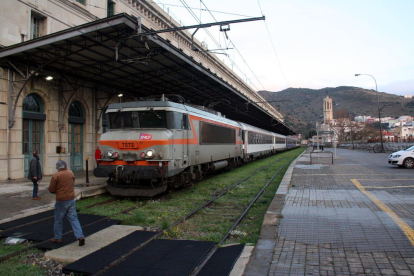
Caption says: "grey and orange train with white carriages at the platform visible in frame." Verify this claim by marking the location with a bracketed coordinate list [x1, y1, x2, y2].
[94, 95, 298, 197]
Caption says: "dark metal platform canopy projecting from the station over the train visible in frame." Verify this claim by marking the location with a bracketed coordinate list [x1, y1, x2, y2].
[0, 14, 295, 135]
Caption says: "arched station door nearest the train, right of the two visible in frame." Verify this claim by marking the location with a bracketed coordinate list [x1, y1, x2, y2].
[68, 102, 85, 171]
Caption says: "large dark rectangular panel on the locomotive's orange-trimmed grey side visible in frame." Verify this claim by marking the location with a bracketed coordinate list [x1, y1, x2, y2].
[200, 122, 236, 144]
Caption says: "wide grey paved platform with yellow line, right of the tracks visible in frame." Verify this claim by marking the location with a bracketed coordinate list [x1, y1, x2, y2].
[243, 149, 414, 276]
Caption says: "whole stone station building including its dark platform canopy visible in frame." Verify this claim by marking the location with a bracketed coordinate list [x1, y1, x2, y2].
[0, 0, 294, 180]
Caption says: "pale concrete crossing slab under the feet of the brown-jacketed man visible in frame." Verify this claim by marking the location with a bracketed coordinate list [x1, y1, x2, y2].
[45, 225, 143, 264]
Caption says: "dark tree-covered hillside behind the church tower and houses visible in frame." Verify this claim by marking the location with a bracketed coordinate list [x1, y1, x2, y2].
[259, 86, 414, 135]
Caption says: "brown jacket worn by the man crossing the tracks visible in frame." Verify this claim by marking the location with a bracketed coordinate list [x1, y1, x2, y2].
[49, 170, 75, 201]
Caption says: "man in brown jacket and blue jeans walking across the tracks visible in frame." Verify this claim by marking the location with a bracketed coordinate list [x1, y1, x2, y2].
[49, 160, 85, 246]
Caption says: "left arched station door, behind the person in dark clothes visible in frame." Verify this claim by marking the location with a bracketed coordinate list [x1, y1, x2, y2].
[22, 94, 46, 176]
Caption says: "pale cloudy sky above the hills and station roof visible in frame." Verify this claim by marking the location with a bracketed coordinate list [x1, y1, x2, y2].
[153, 0, 414, 95]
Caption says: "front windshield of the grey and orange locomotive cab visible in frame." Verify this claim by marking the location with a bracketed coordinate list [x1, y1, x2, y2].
[108, 110, 167, 129]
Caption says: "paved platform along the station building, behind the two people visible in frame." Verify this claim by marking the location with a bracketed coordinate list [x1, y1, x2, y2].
[0, 171, 107, 223]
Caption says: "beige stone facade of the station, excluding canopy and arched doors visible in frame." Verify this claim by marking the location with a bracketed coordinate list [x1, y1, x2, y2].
[0, 0, 282, 180]
